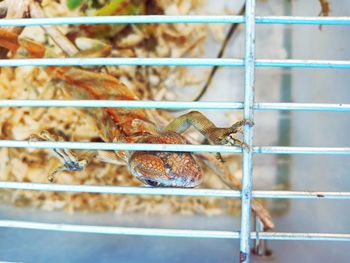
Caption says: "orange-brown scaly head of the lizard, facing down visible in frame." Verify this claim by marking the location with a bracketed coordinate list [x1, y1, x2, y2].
[128, 132, 203, 187]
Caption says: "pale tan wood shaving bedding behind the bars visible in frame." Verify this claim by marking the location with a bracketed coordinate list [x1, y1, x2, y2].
[0, 0, 240, 218]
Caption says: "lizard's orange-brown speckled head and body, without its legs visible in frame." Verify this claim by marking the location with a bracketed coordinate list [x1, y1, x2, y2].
[51, 67, 203, 187]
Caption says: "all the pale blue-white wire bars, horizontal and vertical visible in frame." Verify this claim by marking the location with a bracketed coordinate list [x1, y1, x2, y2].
[0, 0, 350, 262]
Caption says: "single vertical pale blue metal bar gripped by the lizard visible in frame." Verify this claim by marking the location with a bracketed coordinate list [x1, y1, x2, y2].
[240, 0, 255, 263]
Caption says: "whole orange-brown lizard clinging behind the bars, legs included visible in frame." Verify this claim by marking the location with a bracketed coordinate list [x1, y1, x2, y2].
[0, 22, 274, 229]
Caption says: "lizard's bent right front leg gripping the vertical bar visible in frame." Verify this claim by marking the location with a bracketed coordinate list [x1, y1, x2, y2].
[165, 111, 252, 148]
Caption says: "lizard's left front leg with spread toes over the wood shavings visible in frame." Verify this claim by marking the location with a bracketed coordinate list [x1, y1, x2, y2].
[29, 131, 96, 182]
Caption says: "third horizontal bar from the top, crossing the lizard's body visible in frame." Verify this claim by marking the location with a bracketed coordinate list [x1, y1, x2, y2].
[0, 100, 350, 112]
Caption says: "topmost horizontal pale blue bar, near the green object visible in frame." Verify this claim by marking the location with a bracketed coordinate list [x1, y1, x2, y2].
[0, 15, 350, 26]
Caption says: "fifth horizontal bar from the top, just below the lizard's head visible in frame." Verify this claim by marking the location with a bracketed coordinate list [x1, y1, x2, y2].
[0, 181, 350, 200]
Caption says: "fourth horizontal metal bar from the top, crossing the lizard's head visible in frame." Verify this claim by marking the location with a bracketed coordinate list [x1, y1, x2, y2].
[0, 140, 350, 155]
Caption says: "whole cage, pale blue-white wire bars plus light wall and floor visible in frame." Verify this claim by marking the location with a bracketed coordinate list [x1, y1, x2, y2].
[0, 0, 350, 262]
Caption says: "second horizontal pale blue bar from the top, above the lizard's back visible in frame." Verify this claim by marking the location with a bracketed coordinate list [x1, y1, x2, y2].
[0, 58, 350, 69]
